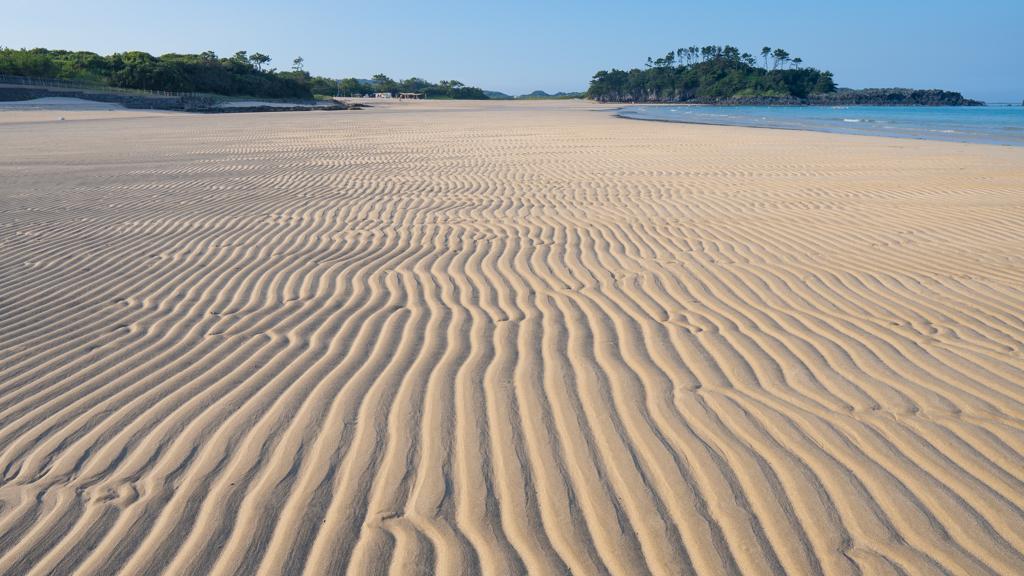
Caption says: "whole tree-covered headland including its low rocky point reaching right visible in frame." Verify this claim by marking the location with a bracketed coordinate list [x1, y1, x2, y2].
[587, 45, 981, 106]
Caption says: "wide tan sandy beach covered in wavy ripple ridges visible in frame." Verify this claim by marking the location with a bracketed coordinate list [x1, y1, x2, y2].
[0, 102, 1024, 576]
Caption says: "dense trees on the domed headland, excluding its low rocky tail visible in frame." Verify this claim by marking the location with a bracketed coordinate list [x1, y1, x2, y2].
[587, 46, 836, 101]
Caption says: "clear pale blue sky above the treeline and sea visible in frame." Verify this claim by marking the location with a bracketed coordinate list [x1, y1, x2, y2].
[0, 0, 1024, 102]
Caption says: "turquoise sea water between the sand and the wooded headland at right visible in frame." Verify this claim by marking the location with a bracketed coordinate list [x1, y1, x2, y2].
[618, 105, 1024, 146]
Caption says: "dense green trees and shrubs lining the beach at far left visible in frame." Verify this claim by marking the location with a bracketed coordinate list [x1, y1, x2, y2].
[0, 48, 312, 98]
